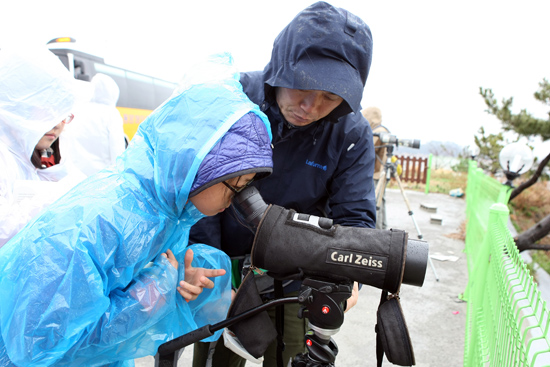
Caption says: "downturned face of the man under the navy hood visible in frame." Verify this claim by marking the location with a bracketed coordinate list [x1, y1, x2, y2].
[275, 87, 343, 126]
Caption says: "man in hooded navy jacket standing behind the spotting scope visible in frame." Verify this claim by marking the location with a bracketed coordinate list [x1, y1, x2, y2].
[191, 2, 376, 367]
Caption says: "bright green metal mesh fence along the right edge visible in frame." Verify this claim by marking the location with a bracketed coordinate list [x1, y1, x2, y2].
[463, 162, 550, 367]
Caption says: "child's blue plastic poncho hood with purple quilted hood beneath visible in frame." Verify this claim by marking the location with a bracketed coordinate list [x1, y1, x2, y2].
[117, 54, 273, 217]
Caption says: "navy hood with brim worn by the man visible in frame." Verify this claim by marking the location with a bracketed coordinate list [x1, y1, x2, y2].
[264, 2, 372, 121]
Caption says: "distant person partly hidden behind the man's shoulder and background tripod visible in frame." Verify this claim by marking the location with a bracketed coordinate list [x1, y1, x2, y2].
[362, 107, 390, 229]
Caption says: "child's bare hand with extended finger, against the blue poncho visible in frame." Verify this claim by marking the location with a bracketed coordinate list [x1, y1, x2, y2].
[178, 249, 225, 302]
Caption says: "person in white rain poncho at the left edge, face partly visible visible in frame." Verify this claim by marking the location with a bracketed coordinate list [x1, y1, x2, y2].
[0, 47, 83, 247]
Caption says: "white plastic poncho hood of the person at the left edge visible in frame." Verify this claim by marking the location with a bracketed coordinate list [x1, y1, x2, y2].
[0, 47, 75, 164]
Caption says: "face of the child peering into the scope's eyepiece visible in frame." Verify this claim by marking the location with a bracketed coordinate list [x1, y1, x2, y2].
[189, 173, 255, 216]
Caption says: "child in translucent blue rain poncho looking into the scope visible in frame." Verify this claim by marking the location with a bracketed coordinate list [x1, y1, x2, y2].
[0, 54, 272, 366]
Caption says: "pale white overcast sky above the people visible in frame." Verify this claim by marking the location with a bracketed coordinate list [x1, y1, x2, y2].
[0, 0, 550, 155]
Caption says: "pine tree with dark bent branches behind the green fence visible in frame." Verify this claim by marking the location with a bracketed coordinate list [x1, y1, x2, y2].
[476, 79, 550, 251]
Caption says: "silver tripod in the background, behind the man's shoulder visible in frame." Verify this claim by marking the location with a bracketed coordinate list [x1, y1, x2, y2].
[375, 144, 439, 282]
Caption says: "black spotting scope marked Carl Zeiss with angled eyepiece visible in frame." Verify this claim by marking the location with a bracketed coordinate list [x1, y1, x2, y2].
[233, 186, 428, 293]
